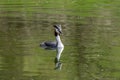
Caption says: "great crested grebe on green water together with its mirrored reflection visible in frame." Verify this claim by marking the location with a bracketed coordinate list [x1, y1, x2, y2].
[40, 25, 64, 69]
